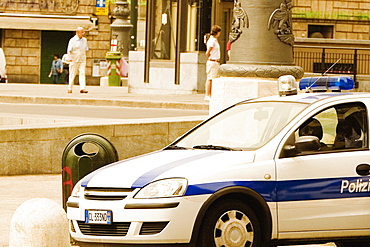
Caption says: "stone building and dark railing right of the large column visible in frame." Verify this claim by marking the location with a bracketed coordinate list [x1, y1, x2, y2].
[292, 0, 370, 91]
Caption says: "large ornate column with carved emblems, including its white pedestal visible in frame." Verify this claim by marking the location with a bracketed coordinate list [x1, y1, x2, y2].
[210, 0, 304, 114]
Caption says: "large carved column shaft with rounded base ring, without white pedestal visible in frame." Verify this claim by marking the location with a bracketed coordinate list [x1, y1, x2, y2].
[220, 0, 303, 78]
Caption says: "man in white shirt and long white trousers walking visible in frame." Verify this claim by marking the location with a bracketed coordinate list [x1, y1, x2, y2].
[67, 27, 89, 93]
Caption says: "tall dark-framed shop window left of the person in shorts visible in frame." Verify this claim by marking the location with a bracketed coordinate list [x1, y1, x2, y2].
[144, 0, 207, 84]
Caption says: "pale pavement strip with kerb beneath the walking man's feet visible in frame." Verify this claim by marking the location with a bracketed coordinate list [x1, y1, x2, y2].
[0, 83, 208, 110]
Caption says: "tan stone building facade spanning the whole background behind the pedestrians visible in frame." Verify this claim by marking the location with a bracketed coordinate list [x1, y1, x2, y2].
[0, 0, 370, 87]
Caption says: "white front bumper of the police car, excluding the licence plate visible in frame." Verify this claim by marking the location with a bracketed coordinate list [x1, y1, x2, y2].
[67, 195, 210, 244]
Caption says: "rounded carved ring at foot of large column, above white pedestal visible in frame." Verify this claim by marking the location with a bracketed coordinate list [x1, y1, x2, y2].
[219, 64, 304, 79]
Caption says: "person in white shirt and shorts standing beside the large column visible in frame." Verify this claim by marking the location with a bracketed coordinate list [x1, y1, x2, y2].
[204, 25, 221, 100]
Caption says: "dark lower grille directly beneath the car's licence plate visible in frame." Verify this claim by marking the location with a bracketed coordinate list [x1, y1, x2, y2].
[77, 221, 130, 237]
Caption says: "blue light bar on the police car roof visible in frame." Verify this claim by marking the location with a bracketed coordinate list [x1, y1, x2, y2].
[299, 76, 355, 91]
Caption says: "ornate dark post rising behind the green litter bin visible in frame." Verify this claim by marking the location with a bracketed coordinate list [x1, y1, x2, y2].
[110, 0, 132, 60]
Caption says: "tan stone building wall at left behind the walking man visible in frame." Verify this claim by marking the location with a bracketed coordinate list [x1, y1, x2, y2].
[0, 0, 111, 84]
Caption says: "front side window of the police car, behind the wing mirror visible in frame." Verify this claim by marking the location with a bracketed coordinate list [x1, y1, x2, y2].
[280, 102, 368, 157]
